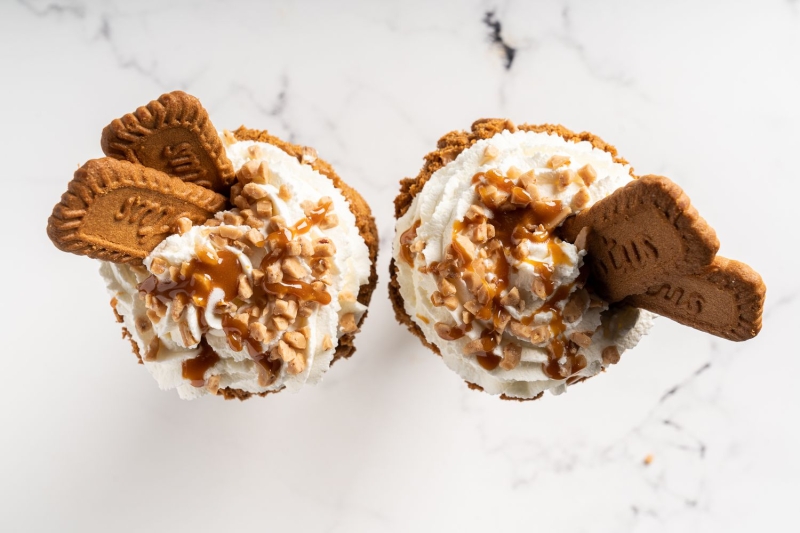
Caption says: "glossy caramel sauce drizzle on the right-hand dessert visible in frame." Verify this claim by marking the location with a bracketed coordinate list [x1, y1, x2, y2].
[424, 169, 588, 380]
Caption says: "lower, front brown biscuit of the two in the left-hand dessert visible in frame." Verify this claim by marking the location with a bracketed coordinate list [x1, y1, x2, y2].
[47, 158, 227, 264]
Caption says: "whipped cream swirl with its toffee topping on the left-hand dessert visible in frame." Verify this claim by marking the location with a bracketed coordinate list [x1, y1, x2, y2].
[100, 135, 371, 399]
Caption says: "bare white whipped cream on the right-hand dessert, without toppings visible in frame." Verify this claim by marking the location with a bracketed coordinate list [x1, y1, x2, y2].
[393, 131, 652, 398]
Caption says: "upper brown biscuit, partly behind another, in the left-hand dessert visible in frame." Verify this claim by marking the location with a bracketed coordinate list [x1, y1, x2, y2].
[100, 91, 234, 192]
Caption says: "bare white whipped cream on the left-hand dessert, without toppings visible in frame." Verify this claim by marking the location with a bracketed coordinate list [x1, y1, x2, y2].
[100, 135, 371, 399]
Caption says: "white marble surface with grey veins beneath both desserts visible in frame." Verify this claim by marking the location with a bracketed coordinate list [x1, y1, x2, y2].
[0, 0, 800, 533]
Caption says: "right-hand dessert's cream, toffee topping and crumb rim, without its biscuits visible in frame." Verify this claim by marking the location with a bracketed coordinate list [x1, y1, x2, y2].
[390, 121, 652, 399]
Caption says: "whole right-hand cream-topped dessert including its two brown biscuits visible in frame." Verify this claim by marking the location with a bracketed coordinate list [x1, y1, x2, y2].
[389, 119, 763, 400]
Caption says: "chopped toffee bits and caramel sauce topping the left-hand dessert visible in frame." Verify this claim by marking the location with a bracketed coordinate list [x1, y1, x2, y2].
[136, 160, 342, 392]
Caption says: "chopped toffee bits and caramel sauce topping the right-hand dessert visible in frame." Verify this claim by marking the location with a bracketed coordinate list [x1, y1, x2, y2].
[400, 166, 614, 380]
